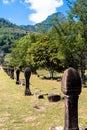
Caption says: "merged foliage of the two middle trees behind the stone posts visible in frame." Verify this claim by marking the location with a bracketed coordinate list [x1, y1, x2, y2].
[10, 32, 62, 76]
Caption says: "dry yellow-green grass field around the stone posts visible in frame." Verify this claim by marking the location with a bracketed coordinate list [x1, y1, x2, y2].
[0, 69, 87, 130]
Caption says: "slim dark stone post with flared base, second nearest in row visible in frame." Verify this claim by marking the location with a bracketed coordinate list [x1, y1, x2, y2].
[24, 67, 31, 96]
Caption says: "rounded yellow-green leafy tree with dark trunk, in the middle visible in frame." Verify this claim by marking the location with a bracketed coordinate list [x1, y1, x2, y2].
[28, 33, 61, 77]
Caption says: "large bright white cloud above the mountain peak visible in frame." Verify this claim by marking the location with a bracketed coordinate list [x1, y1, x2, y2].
[25, 0, 63, 23]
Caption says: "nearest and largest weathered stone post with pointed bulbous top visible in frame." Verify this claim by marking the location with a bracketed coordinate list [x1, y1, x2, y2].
[62, 67, 82, 130]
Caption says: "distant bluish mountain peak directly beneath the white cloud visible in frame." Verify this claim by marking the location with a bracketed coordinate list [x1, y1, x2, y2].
[21, 12, 66, 32]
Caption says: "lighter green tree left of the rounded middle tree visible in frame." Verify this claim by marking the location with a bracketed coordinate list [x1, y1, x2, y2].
[10, 34, 35, 67]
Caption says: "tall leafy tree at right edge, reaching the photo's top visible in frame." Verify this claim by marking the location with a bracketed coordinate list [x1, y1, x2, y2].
[54, 0, 87, 80]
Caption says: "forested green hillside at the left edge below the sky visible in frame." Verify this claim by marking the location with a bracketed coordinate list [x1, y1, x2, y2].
[0, 18, 27, 53]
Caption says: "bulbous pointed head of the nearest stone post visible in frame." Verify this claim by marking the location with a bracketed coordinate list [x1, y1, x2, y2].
[61, 67, 82, 95]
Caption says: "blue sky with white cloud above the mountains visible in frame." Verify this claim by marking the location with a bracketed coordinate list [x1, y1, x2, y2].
[0, 0, 68, 25]
